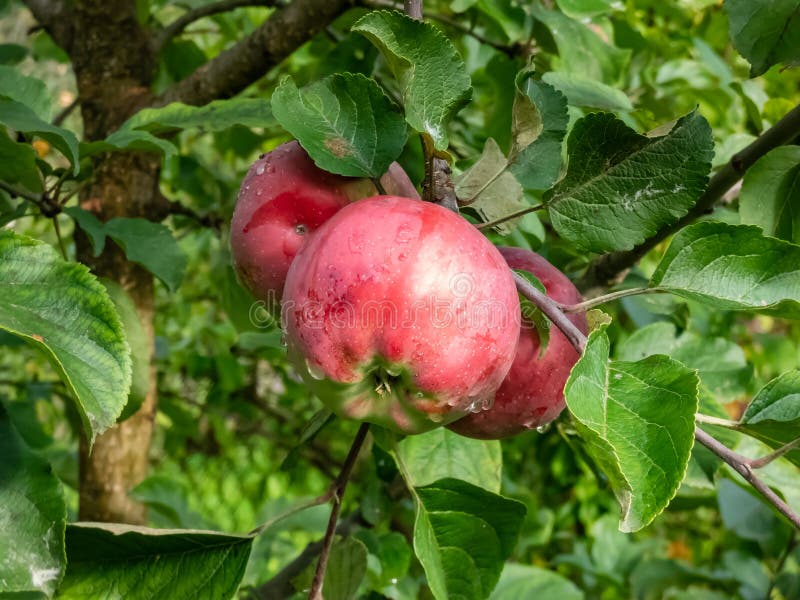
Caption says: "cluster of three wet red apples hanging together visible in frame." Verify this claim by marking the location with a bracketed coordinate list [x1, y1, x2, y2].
[231, 142, 586, 439]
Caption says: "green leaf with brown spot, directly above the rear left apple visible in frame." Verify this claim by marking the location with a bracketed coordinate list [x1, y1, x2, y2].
[272, 73, 407, 178]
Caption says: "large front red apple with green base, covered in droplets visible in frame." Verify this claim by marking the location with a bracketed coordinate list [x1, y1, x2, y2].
[281, 196, 520, 434]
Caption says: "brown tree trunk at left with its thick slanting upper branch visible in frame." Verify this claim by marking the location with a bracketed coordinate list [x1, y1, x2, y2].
[25, 0, 352, 524]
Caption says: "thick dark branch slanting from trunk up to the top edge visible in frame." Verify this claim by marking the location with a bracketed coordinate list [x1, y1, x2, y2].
[155, 0, 352, 105]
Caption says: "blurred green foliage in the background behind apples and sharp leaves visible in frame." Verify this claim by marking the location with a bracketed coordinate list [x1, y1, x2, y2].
[0, 0, 800, 599]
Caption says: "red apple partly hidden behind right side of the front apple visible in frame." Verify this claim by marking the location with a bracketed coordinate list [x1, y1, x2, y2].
[449, 248, 588, 440]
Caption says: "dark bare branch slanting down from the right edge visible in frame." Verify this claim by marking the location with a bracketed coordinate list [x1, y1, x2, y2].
[579, 105, 800, 290]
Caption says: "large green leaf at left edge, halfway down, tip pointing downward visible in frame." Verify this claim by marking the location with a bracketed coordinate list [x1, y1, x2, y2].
[0, 232, 131, 444]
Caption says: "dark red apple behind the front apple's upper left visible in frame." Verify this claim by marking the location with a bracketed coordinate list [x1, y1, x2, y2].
[231, 141, 419, 309]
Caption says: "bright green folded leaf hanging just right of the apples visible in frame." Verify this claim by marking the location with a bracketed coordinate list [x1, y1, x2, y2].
[564, 327, 699, 531]
